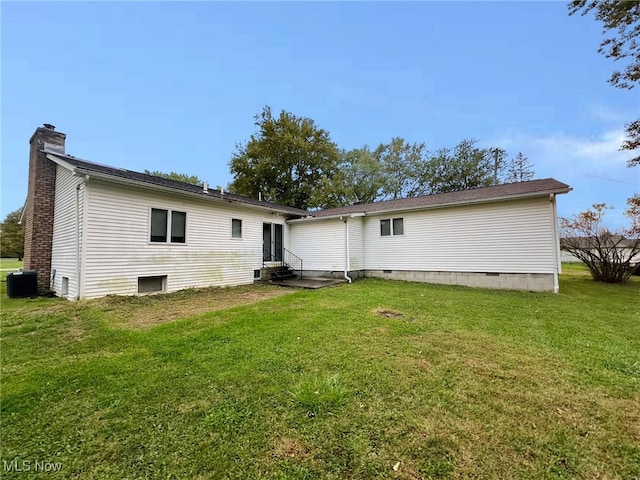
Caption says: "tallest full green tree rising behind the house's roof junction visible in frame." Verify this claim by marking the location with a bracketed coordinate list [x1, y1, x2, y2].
[229, 106, 340, 209]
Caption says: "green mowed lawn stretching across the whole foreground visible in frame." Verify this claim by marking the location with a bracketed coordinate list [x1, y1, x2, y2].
[0, 266, 640, 479]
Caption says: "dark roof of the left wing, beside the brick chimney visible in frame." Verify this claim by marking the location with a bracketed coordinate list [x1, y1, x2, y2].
[44, 149, 308, 216]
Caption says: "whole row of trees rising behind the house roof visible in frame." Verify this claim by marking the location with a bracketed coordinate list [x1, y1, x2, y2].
[229, 106, 534, 210]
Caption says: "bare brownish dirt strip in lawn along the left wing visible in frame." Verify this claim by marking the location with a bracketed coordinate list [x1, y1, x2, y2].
[94, 284, 296, 328]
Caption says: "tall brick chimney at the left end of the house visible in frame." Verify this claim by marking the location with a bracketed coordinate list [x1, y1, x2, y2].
[24, 123, 66, 293]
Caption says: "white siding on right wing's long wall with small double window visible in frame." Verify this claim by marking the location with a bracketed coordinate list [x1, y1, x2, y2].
[364, 197, 555, 273]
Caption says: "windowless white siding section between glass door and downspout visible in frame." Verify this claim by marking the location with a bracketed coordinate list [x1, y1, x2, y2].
[289, 219, 344, 272]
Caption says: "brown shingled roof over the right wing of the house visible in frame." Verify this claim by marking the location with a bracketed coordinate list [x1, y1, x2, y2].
[312, 178, 571, 218]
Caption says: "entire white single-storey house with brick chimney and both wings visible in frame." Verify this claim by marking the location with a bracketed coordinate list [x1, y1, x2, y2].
[24, 125, 570, 299]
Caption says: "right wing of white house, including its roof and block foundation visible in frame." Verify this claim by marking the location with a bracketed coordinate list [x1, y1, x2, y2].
[288, 179, 570, 291]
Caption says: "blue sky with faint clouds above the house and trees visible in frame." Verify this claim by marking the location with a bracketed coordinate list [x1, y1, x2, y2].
[0, 2, 640, 226]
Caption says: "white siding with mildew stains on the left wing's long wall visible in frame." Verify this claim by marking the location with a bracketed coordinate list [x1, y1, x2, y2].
[83, 179, 288, 298]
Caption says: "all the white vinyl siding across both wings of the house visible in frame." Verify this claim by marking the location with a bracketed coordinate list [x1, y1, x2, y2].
[52, 167, 557, 298]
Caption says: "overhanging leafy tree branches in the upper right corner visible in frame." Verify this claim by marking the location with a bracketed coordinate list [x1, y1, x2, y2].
[569, 0, 640, 167]
